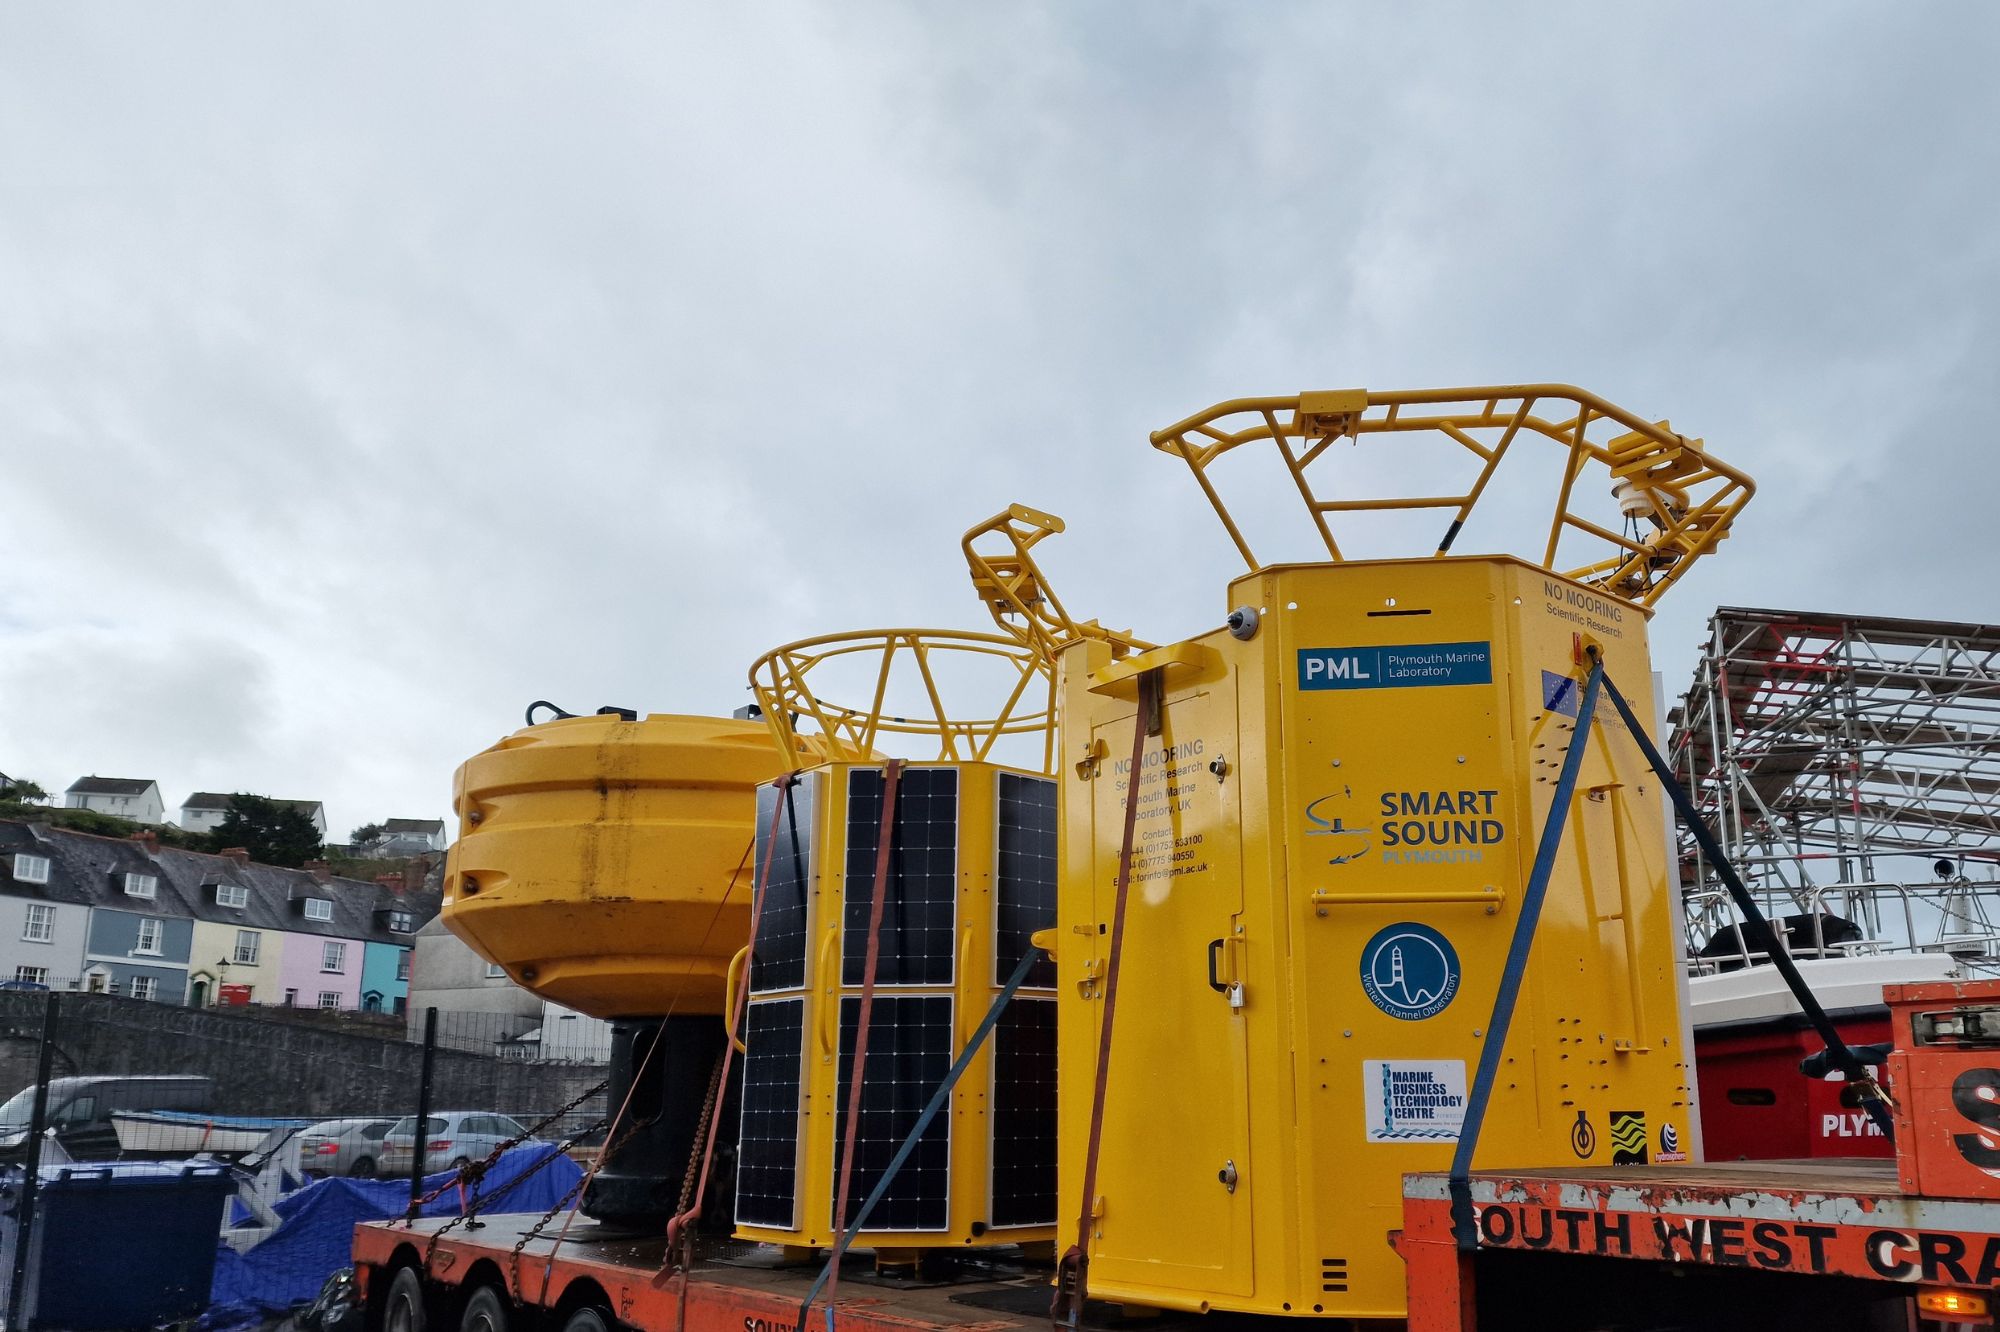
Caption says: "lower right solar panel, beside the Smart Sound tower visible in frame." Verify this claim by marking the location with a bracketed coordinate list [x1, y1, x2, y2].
[988, 996, 1056, 1228]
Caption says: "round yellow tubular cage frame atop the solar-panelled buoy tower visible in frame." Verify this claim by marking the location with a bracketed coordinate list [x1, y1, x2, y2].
[750, 628, 1056, 772]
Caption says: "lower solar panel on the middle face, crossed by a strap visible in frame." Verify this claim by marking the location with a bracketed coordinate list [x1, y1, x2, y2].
[832, 994, 952, 1230]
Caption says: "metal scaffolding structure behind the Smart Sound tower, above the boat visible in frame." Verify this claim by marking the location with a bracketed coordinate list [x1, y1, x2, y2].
[1670, 606, 2000, 974]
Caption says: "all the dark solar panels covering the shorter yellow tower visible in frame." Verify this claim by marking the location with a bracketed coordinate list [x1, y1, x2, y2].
[736, 766, 1058, 1234]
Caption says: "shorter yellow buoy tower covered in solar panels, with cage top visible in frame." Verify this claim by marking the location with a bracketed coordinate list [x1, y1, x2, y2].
[732, 630, 1056, 1262]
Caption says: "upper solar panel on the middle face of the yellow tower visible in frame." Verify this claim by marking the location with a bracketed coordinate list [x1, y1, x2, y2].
[840, 768, 958, 986]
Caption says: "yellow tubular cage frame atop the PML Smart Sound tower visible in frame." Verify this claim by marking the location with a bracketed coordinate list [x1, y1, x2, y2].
[1152, 384, 1756, 606]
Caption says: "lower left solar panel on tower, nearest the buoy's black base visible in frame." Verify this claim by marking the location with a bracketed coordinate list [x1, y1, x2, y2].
[736, 998, 806, 1230]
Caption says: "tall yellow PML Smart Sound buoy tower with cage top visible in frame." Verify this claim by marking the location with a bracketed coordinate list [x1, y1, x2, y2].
[1054, 386, 1750, 1320]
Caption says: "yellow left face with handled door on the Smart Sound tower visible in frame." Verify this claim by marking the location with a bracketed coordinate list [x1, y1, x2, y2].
[1058, 670, 1254, 1308]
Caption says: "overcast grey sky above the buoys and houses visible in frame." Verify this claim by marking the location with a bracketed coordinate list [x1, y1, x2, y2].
[0, 4, 2000, 836]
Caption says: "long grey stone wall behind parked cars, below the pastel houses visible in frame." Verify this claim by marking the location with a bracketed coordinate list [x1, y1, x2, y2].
[0, 990, 604, 1124]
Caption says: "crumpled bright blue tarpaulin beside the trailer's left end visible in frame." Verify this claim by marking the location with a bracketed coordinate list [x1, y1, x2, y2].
[202, 1144, 584, 1330]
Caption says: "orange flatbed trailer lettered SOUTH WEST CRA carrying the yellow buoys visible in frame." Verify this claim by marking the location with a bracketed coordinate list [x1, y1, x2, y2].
[354, 980, 2000, 1332]
